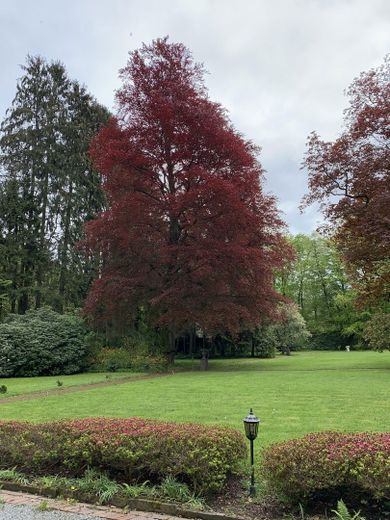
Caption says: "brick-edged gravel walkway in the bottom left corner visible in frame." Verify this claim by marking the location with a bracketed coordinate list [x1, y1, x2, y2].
[0, 490, 182, 520]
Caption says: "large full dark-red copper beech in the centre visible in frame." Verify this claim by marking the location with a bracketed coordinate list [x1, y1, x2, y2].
[85, 38, 291, 354]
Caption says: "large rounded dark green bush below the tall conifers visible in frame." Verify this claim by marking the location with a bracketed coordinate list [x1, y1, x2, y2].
[0, 308, 87, 377]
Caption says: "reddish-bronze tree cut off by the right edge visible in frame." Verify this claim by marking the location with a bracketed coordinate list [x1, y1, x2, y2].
[304, 56, 390, 305]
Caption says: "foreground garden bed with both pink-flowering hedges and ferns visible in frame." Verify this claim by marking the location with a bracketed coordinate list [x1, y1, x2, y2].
[0, 418, 390, 520]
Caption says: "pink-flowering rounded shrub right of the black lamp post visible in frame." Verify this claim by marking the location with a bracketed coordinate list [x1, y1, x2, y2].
[262, 432, 390, 502]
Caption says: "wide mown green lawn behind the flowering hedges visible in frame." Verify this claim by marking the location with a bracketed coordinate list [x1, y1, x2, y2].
[0, 352, 390, 447]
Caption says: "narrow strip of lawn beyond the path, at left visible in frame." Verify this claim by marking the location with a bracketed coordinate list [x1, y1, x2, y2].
[0, 372, 140, 396]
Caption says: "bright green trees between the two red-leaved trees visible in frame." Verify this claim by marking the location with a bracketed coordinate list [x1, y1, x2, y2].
[275, 234, 370, 349]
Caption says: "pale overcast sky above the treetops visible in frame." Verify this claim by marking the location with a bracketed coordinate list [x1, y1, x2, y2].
[0, 0, 390, 233]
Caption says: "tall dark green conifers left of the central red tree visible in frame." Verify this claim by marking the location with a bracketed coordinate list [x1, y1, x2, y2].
[0, 57, 108, 314]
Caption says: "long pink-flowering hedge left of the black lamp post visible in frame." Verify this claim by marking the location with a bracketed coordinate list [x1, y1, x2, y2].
[0, 418, 246, 493]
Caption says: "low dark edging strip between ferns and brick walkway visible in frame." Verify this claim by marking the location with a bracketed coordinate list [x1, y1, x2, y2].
[0, 480, 243, 520]
